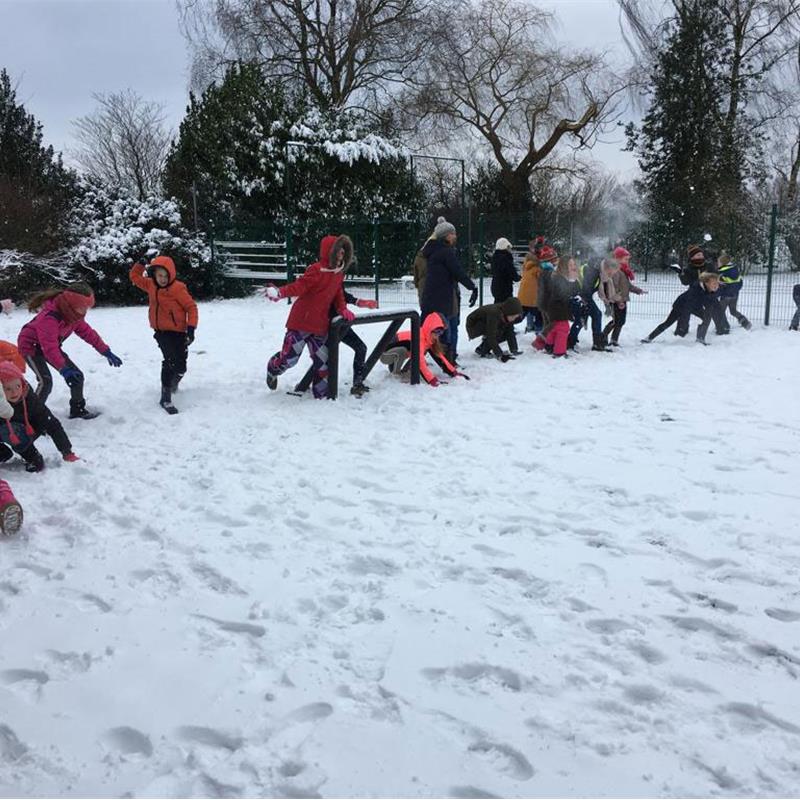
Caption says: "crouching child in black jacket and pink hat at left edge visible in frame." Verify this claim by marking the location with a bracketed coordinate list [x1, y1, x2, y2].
[0, 361, 78, 472]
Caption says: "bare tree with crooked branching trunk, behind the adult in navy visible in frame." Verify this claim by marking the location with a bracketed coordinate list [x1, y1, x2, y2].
[408, 0, 621, 210]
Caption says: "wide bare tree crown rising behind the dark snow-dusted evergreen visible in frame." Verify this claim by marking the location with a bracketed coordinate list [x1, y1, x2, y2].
[178, 0, 429, 110]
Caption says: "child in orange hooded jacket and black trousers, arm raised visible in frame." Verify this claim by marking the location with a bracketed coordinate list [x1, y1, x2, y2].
[130, 256, 197, 414]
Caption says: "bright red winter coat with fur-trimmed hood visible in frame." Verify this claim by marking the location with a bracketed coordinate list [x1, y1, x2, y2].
[278, 236, 353, 336]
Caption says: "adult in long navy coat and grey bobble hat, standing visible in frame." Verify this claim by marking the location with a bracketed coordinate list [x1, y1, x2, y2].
[420, 217, 478, 361]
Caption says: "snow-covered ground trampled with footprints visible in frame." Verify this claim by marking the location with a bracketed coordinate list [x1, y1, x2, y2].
[0, 300, 800, 797]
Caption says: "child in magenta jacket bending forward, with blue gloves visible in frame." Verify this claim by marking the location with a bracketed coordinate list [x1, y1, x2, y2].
[17, 283, 122, 419]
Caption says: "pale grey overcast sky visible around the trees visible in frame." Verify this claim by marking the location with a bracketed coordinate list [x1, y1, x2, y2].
[0, 0, 635, 177]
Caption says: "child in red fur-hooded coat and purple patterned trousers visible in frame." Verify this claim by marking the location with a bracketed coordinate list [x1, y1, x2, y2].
[265, 236, 354, 400]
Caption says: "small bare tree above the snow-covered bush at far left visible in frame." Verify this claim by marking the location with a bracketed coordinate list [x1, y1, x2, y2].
[72, 89, 170, 200]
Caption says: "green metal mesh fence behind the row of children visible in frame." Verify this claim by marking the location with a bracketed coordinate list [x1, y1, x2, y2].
[212, 206, 800, 325]
